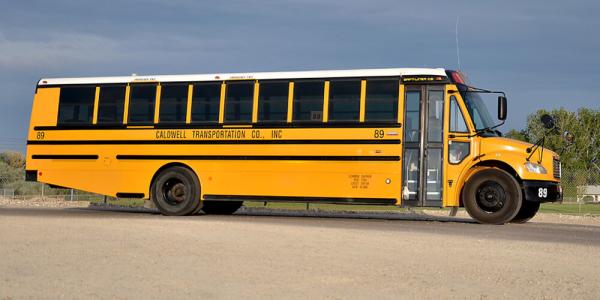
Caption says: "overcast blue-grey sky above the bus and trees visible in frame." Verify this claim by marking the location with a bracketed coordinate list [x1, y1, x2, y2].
[0, 0, 600, 151]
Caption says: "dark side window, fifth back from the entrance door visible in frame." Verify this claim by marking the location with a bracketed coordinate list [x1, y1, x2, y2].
[225, 82, 254, 123]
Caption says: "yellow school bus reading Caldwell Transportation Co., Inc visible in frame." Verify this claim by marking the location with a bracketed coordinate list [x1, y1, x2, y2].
[26, 68, 562, 224]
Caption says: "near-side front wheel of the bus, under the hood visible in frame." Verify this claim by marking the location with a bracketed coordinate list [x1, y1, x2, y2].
[462, 169, 523, 224]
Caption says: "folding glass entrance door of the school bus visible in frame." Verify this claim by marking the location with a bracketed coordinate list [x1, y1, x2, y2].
[402, 85, 444, 207]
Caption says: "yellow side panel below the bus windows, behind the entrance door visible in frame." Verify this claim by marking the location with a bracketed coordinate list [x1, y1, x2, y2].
[29, 129, 401, 201]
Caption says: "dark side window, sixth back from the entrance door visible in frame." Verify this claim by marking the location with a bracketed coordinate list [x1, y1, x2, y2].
[192, 82, 221, 123]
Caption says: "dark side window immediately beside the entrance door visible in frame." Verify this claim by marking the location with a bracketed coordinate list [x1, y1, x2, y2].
[365, 79, 400, 123]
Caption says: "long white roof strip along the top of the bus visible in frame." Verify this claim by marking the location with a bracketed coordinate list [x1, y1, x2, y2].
[38, 68, 446, 86]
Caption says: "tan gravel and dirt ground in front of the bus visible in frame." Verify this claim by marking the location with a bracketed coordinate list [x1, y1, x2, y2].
[0, 207, 600, 299]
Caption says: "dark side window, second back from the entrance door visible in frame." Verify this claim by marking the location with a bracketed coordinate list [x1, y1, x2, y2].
[329, 80, 360, 122]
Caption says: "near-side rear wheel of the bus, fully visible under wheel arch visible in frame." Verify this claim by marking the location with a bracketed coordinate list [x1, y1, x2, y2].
[151, 167, 201, 216]
